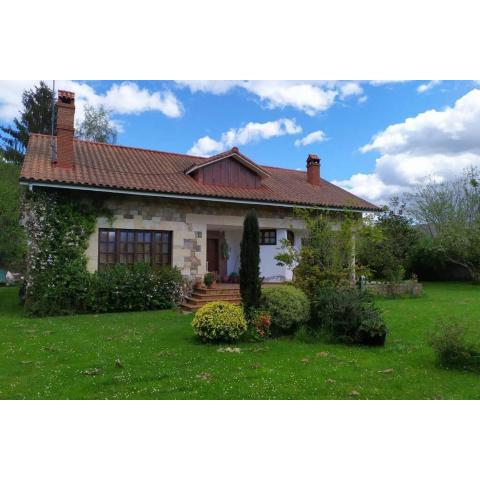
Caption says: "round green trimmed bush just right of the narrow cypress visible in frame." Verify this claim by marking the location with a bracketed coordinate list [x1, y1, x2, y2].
[261, 285, 310, 333]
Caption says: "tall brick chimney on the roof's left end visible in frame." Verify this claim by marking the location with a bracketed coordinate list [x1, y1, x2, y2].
[57, 90, 75, 168]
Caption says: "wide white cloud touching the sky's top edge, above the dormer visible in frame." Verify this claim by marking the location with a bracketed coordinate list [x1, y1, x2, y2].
[177, 80, 363, 116]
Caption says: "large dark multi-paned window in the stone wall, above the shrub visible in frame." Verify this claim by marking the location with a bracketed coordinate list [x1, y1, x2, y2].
[98, 228, 172, 270]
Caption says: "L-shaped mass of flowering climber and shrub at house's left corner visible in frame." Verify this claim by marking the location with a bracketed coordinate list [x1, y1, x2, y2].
[24, 191, 183, 316]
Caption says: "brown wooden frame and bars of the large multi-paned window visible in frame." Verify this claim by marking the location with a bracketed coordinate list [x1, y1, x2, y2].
[97, 228, 173, 271]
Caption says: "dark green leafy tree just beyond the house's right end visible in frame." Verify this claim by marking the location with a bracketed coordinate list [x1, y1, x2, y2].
[357, 197, 419, 282]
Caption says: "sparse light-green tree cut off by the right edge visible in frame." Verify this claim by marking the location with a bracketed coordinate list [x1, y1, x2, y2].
[407, 167, 480, 282]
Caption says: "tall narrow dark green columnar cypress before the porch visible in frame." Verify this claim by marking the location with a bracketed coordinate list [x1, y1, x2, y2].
[239, 210, 262, 316]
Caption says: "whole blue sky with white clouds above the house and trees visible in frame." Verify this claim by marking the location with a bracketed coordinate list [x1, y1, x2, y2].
[0, 80, 480, 203]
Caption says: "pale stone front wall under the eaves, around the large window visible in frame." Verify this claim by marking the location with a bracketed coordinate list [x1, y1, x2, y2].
[83, 194, 303, 279]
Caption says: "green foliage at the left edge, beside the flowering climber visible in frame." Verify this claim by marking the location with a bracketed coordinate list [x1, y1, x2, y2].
[0, 159, 26, 270]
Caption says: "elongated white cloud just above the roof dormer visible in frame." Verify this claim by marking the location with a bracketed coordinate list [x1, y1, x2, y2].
[188, 118, 302, 156]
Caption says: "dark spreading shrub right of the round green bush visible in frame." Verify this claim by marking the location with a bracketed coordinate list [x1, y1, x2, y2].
[311, 287, 384, 342]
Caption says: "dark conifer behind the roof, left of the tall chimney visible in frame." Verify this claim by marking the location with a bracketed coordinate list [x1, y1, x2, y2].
[0, 82, 54, 164]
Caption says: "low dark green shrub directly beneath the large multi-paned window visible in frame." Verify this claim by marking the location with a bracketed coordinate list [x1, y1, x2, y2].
[83, 263, 183, 313]
